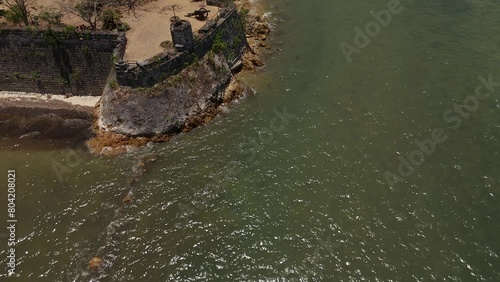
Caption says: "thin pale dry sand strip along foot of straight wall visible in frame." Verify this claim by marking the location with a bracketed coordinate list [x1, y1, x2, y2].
[0, 91, 101, 108]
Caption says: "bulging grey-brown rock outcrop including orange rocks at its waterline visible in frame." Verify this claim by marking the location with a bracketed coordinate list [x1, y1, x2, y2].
[87, 53, 253, 156]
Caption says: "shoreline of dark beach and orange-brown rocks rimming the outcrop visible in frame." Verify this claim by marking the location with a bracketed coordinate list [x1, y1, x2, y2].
[0, 0, 271, 156]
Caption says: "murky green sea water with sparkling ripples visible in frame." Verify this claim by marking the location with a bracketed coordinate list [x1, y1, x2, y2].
[0, 0, 500, 282]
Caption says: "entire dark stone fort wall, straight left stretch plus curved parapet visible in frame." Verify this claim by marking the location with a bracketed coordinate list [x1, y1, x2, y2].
[0, 3, 247, 96]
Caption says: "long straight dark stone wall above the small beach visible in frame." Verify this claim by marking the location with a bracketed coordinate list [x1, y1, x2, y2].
[0, 28, 126, 96]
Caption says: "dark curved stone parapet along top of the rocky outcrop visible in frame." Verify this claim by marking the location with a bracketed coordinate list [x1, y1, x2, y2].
[116, 6, 247, 87]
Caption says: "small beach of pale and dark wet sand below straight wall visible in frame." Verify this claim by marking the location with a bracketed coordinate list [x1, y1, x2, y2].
[0, 91, 95, 149]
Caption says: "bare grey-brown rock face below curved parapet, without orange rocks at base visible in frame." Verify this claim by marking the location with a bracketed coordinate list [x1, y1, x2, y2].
[99, 52, 232, 136]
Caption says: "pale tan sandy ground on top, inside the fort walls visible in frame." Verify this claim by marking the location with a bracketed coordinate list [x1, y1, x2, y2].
[0, 0, 218, 61]
